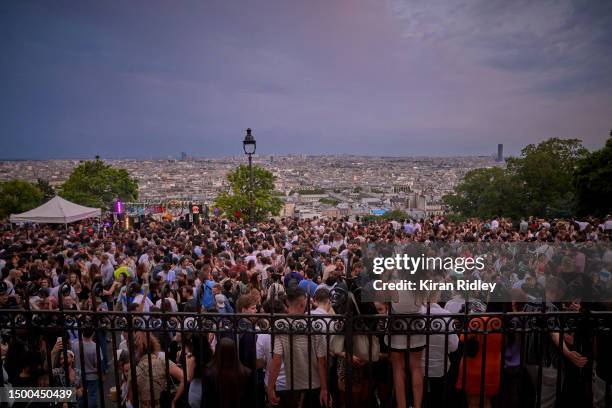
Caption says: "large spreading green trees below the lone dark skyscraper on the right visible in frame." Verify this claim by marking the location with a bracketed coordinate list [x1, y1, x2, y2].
[443, 138, 588, 218]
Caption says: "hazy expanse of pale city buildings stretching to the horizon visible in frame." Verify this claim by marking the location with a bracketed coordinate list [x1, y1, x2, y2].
[0, 152, 504, 218]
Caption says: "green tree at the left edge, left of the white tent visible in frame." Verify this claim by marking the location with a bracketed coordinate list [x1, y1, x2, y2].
[0, 180, 44, 218]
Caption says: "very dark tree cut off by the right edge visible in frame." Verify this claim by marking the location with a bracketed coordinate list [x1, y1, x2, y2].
[574, 137, 612, 216]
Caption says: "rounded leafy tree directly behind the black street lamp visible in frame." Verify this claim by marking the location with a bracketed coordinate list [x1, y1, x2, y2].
[215, 165, 283, 221]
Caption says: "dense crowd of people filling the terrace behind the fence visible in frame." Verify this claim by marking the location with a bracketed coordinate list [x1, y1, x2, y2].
[0, 216, 612, 408]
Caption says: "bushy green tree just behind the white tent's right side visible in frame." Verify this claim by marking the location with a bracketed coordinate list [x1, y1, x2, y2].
[61, 158, 138, 208]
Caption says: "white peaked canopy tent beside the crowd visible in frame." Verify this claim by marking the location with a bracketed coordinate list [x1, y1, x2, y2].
[10, 196, 102, 224]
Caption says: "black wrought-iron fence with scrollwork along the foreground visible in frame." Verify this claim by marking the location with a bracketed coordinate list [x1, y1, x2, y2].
[0, 305, 612, 407]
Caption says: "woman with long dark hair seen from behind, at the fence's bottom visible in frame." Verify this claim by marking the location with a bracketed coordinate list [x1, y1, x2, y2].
[203, 337, 254, 408]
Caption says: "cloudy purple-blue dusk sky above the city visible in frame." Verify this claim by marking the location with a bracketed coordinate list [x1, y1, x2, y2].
[0, 0, 612, 158]
